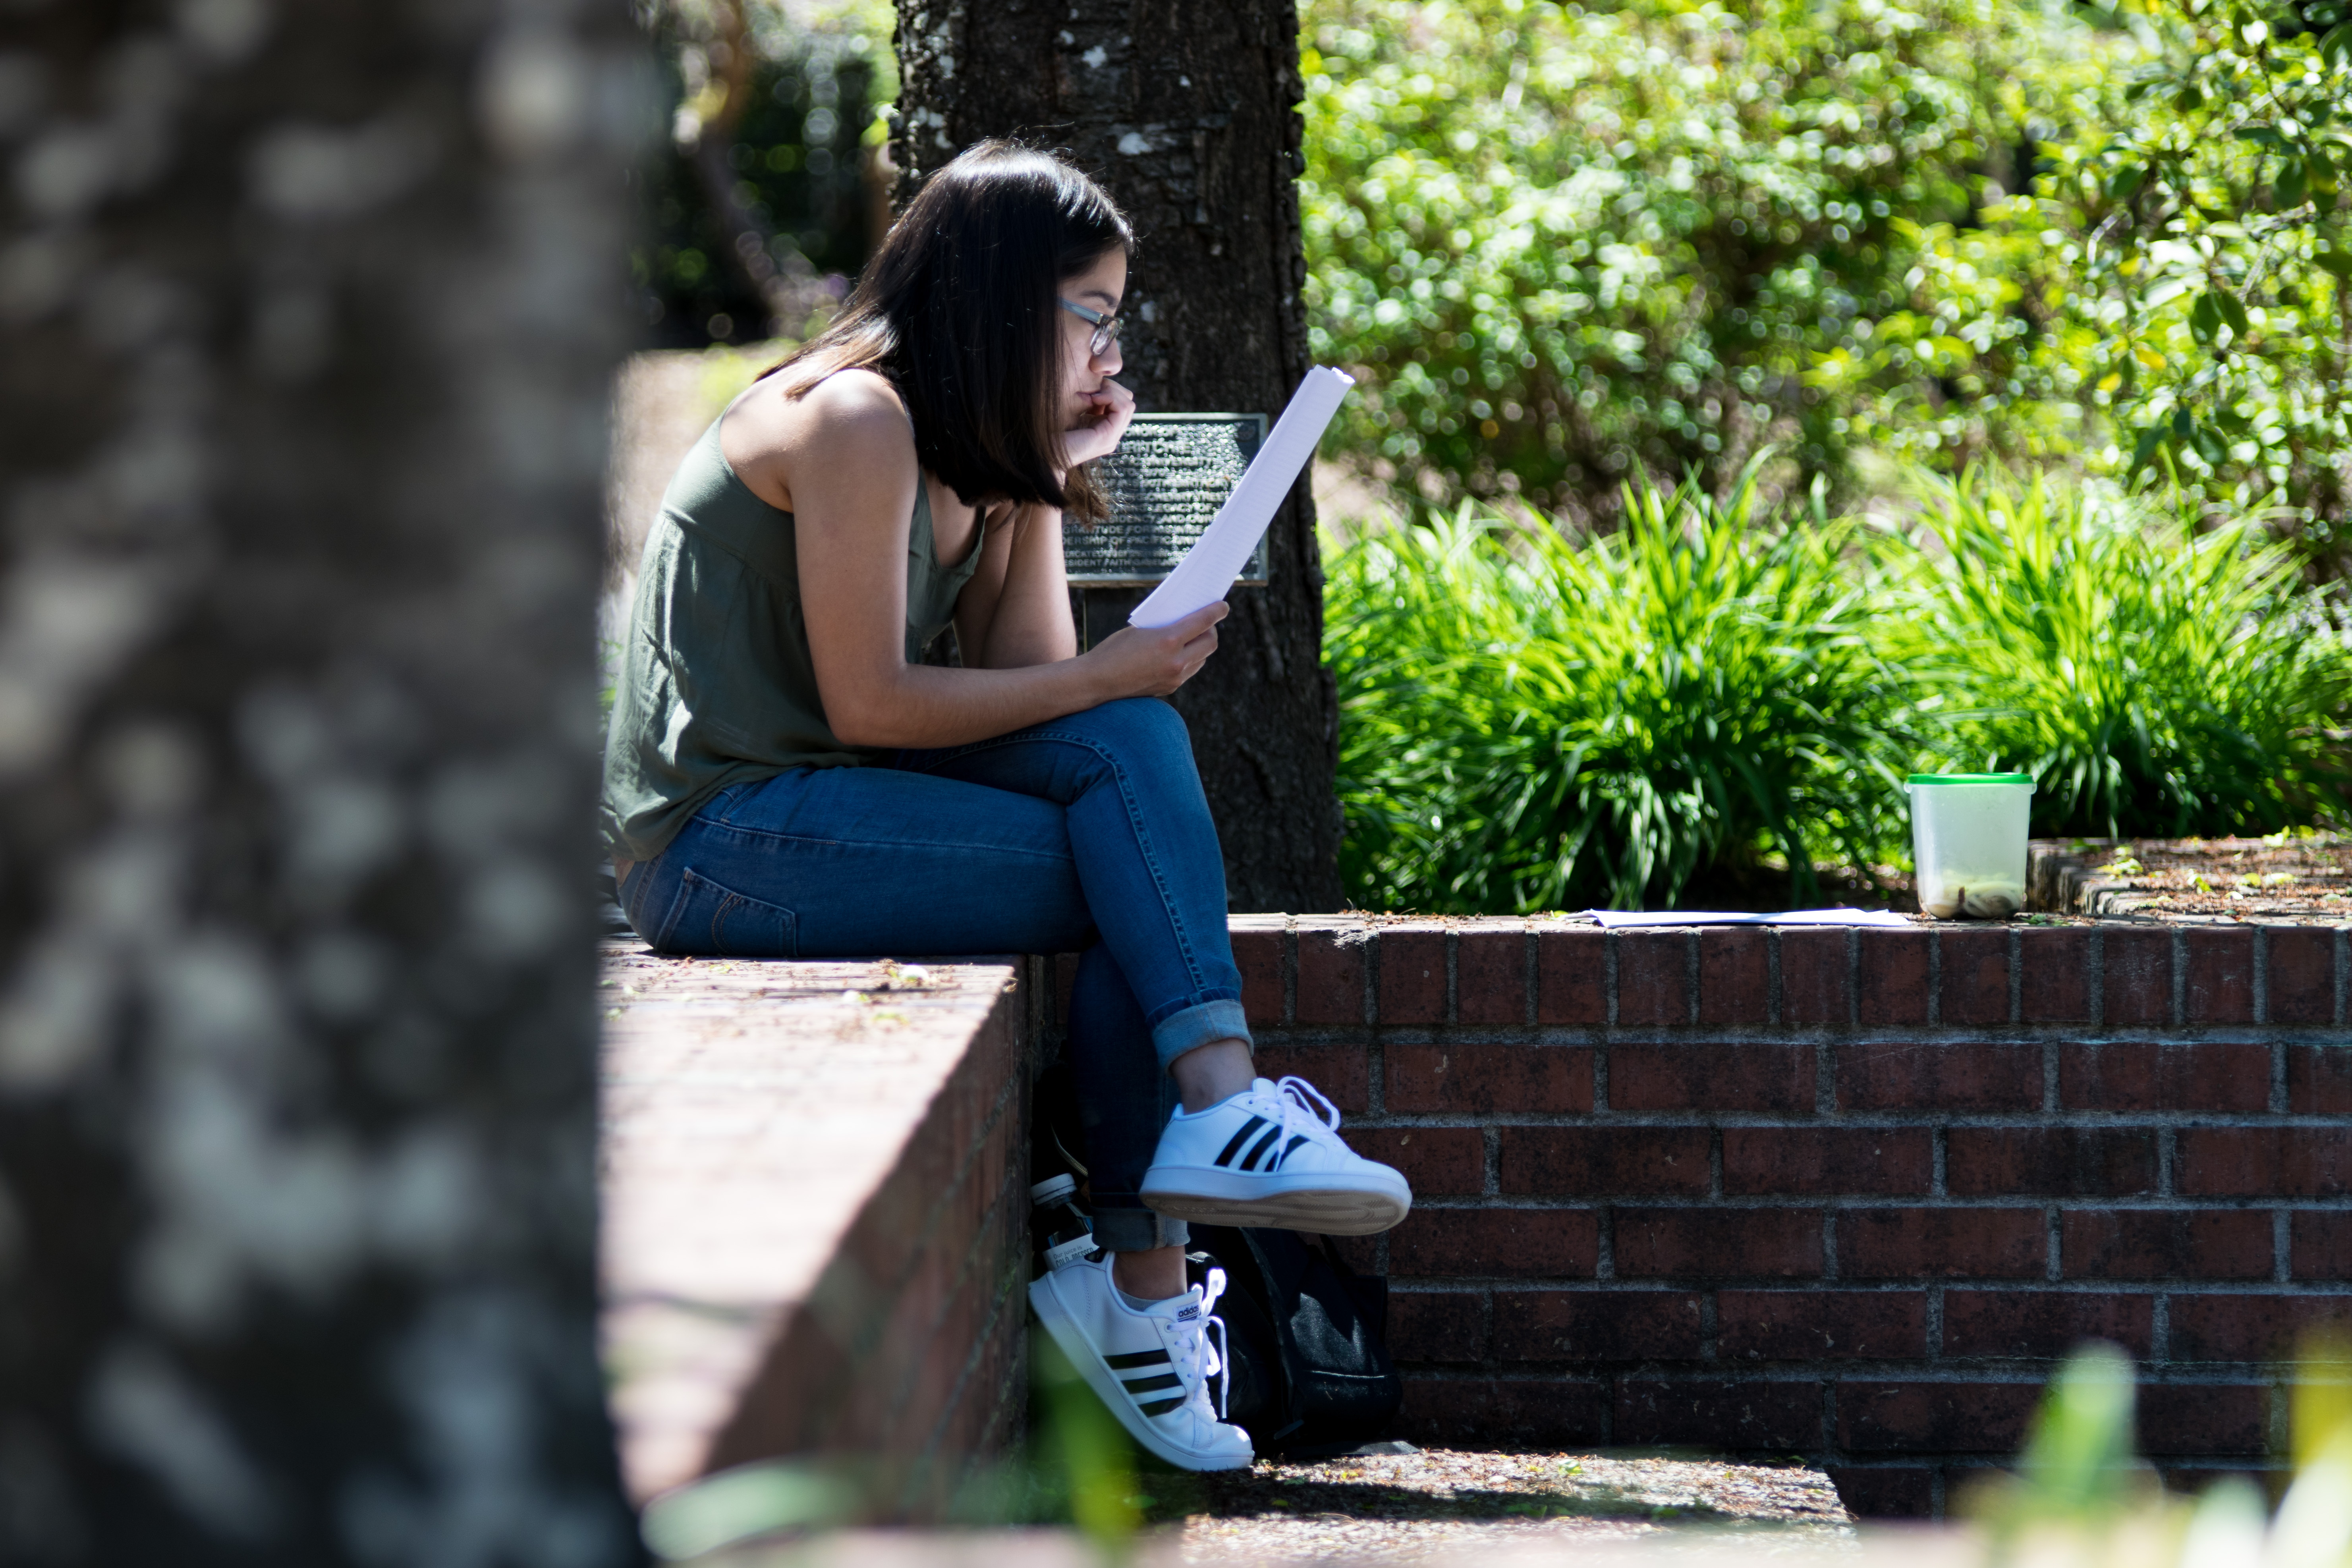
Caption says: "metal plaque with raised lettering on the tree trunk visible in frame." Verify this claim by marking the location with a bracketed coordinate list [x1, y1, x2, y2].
[1061, 414, 1265, 588]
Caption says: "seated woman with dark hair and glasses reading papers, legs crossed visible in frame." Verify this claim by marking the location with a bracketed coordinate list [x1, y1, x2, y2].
[604, 143, 1411, 1469]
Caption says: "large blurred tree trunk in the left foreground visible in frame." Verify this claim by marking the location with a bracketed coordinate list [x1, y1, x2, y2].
[0, 0, 649, 1568]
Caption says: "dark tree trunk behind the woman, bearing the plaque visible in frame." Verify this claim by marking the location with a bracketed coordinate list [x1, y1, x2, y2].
[891, 0, 1341, 910]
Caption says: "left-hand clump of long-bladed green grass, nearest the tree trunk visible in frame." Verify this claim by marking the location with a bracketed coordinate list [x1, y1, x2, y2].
[1327, 468, 1905, 912]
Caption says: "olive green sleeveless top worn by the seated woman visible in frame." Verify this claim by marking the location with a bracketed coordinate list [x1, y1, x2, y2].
[604, 414, 981, 860]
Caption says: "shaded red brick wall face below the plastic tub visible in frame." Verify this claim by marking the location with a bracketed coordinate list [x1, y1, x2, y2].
[1232, 917, 2352, 1514]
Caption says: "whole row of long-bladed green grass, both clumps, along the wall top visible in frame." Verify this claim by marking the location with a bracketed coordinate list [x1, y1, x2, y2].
[1324, 468, 2352, 912]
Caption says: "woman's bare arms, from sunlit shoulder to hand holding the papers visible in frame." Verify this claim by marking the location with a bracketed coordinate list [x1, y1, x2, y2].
[753, 371, 1225, 747]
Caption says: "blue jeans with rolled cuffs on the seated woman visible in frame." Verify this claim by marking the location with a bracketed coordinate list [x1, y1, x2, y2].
[621, 698, 1249, 1251]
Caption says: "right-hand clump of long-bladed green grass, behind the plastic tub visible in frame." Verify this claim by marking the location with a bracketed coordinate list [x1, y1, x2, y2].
[1879, 470, 2352, 837]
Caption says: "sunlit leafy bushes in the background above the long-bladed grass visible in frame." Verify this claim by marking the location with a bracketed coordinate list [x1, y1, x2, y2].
[1301, 0, 2352, 564]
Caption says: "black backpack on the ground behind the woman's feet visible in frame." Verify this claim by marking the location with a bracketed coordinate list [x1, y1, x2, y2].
[1188, 1225, 1404, 1460]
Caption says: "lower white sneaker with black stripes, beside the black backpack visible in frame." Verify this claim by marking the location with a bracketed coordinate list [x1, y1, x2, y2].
[1030, 1253, 1256, 1469]
